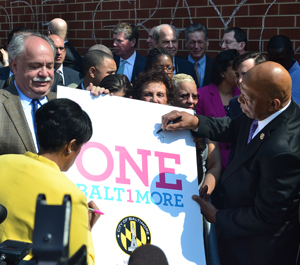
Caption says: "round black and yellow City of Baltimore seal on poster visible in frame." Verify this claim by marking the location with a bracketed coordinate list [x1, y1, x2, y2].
[116, 216, 151, 255]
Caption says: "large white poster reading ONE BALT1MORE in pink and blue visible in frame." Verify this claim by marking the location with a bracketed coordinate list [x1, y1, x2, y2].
[58, 87, 206, 265]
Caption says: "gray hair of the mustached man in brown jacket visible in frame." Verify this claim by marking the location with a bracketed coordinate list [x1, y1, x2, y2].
[8, 32, 56, 67]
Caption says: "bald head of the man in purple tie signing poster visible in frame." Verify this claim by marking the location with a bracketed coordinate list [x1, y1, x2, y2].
[239, 62, 292, 120]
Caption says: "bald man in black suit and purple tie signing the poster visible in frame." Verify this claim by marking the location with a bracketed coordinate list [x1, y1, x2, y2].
[162, 62, 300, 265]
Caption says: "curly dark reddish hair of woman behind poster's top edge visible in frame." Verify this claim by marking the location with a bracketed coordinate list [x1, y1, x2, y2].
[133, 70, 174, 103]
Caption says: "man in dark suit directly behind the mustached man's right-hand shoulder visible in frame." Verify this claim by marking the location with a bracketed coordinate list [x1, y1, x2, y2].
[49, 34, 83, 86]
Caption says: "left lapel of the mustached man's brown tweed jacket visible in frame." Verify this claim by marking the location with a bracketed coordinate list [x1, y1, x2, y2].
[3, 85, 36, 150]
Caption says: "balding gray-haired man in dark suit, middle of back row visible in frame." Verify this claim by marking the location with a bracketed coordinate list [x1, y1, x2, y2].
[152, 24, 199, 87]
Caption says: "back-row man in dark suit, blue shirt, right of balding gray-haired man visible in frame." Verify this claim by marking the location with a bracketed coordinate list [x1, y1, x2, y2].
[185, 23, 213, 87]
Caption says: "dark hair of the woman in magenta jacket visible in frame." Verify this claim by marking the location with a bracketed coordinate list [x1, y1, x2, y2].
[211, 49, 239, 86]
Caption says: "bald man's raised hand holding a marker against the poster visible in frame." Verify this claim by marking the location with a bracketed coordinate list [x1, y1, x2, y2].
[161, 110, 199, 131]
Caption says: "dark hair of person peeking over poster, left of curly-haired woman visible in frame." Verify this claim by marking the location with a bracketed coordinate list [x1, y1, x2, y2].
[99, 74, 133, 98]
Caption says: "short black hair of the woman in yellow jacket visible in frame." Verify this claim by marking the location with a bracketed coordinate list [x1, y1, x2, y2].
[35, 98, 93, 153]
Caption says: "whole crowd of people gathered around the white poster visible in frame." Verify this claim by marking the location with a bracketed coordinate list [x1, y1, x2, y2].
[0, 18, 300, 265]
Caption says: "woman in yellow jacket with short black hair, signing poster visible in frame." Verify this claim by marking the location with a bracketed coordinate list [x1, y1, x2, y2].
[0, 99, 98, 265]
